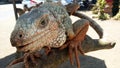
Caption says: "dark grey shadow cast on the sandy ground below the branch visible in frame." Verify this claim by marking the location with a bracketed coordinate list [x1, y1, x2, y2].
[0, 53, 107, 68]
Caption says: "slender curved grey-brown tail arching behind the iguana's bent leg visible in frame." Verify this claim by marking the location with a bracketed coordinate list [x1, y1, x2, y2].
[72, 11, 103, 38]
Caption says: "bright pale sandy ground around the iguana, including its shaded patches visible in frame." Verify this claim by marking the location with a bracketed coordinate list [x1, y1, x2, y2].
[0, 5, 120, 68]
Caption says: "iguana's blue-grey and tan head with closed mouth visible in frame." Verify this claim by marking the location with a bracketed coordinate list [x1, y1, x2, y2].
[10, 9, 66, 52]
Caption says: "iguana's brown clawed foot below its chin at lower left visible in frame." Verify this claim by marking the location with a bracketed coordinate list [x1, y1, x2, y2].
[8, 52, 41, 68]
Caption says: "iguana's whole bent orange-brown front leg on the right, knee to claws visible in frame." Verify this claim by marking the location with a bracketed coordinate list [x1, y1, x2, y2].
[61, 19, 89, 68]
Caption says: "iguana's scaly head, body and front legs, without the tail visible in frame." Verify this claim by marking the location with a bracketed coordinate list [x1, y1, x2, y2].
[10, 2, 89, 68]
